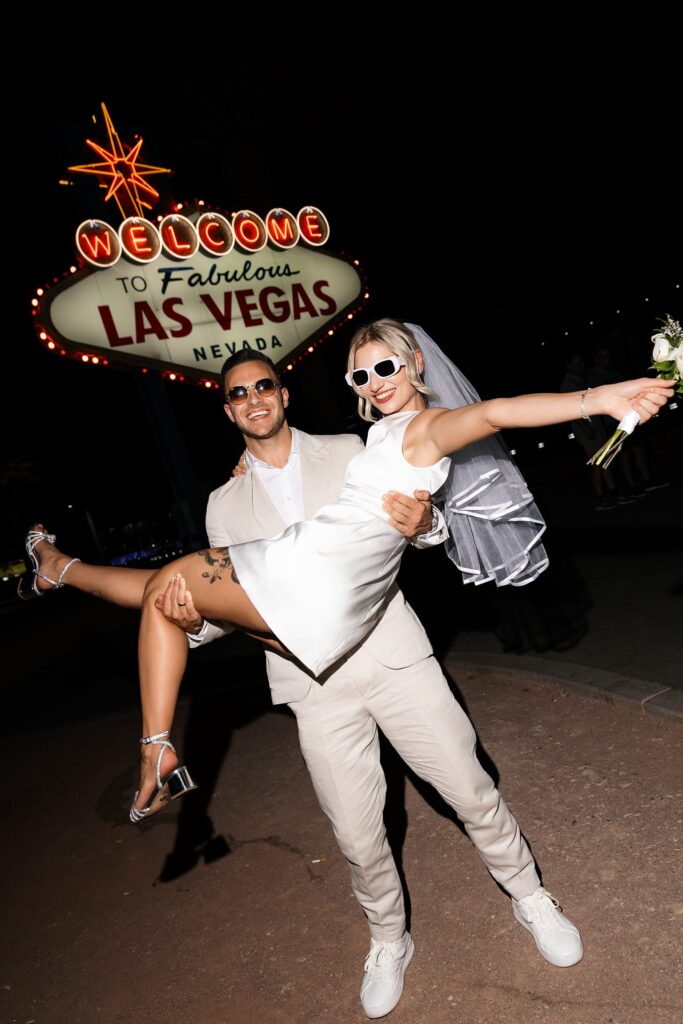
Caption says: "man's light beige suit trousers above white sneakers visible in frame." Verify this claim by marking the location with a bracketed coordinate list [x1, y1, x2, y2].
[289, 648, 541, 942]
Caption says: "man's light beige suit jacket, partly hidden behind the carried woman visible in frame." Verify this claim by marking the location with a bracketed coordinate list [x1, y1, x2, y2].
[201, 430, 442, 703]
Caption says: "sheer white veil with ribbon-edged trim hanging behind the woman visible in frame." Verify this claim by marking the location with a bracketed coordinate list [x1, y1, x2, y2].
[405, 324, 549, 587]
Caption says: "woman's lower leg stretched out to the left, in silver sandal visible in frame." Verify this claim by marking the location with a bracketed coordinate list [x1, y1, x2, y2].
[31, 523, 153, 608]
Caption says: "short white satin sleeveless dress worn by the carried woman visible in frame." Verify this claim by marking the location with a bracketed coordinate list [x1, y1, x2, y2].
[230, 412, 451, 676]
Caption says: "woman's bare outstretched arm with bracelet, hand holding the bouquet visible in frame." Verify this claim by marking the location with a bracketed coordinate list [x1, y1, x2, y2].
[403, 377, 674, 466]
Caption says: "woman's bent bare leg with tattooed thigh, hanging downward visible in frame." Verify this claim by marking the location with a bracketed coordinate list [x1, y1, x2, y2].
[135, 548, 276, 808]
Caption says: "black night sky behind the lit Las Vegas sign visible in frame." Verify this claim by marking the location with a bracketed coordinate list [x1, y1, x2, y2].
[0, 3, 683, 558]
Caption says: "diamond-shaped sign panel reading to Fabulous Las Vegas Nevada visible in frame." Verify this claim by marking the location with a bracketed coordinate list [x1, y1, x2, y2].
[37, 239, 364, 380]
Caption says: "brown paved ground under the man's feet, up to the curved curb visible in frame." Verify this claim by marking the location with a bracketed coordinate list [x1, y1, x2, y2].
[0, 660, 683, 1024]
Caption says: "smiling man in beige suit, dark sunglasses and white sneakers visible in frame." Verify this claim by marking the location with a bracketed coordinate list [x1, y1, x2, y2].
[157, 350, 583, 1018]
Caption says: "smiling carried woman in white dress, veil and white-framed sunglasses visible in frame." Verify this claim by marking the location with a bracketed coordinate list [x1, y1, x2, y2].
[20, 319, 674, 821]
